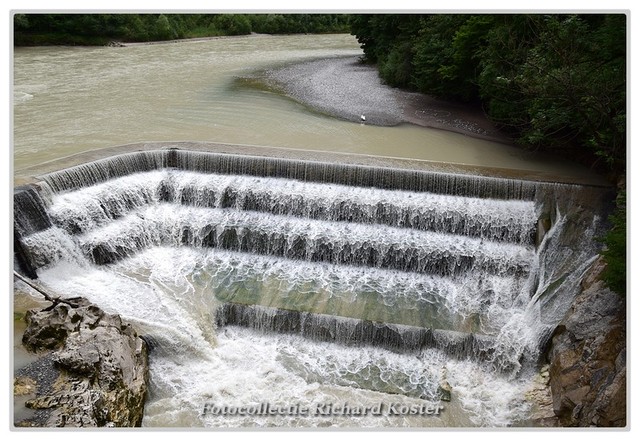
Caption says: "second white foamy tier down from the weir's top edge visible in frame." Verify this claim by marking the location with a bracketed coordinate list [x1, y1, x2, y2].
[79, 204, 533, 260]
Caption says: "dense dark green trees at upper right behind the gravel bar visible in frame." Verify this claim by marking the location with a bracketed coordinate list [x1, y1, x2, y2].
[352, 14, 626, 173]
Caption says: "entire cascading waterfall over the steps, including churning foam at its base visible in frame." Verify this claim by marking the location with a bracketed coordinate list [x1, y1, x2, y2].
[14, 149, 599, 427]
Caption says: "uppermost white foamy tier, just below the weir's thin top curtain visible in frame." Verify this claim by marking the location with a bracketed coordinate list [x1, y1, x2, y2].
[43, 170, 536, 243]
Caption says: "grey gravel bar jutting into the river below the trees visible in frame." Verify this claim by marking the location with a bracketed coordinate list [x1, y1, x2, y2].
[264, 57, 511, 143]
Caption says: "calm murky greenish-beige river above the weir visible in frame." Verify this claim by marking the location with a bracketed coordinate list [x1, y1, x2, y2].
[13, 31, 604, 182]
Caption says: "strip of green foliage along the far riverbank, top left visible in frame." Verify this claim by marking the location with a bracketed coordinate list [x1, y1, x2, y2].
[14, 14, 349, 45]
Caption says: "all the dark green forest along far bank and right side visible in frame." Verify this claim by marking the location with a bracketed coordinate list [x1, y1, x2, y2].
[13, 14, 627, 292]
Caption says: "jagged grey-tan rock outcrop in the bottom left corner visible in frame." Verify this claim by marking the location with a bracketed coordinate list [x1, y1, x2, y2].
[14, 298, 148, 427]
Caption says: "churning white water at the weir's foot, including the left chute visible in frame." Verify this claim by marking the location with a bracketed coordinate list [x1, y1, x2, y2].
[40, 244, 527, 427]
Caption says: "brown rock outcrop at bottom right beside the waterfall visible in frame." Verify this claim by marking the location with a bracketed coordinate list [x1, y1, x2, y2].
[549, 254, 627, 427]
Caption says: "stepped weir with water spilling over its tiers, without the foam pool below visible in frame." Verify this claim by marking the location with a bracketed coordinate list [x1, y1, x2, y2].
[14, 148, 609, 426]
